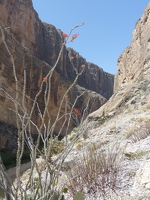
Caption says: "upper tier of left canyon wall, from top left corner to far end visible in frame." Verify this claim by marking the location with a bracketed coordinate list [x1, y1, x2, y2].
[0, 0, 114, 99]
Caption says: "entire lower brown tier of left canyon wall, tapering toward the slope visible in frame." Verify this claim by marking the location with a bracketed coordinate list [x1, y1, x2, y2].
[0, 24, 107, 149]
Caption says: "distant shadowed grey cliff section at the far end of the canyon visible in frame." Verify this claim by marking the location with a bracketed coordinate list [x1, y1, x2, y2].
[66, 48, 114, 99]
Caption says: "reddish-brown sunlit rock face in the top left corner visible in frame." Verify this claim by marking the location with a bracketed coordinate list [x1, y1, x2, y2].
[0, 0, 37, 52]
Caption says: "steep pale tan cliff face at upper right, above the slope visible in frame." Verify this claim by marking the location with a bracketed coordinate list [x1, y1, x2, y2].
[114, 3, 150, 91]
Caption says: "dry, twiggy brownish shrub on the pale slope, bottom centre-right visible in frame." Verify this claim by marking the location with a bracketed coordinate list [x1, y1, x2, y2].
[66, 143, 121, 197]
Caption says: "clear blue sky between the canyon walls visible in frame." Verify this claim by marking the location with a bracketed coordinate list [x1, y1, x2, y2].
[32, 0, 150, 74]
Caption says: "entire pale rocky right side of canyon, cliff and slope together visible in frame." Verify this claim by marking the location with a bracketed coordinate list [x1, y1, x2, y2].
[60, 3, 150, 200]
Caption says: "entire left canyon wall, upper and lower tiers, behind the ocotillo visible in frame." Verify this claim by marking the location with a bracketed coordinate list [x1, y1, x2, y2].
[0, 0, 114, 150]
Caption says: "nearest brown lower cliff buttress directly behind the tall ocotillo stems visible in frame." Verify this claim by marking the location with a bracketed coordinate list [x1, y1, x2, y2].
[0, 25, 70, 138]
